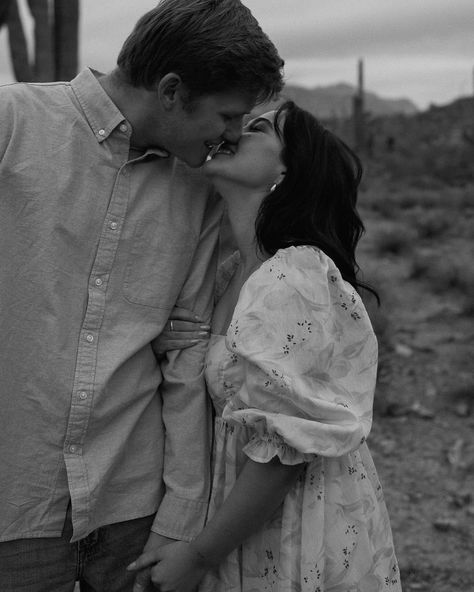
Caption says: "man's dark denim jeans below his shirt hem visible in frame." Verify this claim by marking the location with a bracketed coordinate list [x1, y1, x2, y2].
[0, 504, 154, 592]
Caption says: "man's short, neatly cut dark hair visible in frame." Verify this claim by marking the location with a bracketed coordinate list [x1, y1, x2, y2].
[117, 0, 284, 103]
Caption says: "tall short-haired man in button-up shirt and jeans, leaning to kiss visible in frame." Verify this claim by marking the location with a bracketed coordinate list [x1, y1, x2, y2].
[0, 0, 283, 592]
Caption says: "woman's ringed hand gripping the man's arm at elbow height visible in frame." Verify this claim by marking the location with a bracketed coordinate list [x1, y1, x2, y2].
[153, 307, 211, 356]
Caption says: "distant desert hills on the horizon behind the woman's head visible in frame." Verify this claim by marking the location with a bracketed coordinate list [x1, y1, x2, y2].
[254, 91, 474, 187]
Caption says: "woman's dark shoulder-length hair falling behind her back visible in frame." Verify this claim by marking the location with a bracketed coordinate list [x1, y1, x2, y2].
[256, 101, 379, 301]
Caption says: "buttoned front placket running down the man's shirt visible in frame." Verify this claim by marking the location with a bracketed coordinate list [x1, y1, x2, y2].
[63, 153, 131, 540]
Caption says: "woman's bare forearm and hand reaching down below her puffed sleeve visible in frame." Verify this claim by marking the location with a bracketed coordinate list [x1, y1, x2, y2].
[129, 457, 303, 592]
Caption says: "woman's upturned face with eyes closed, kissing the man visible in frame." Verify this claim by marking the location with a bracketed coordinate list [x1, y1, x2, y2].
[203, 111, 285, 188]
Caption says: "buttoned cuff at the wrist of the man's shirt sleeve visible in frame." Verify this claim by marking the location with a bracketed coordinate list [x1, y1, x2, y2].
[151, 493, 208, 542]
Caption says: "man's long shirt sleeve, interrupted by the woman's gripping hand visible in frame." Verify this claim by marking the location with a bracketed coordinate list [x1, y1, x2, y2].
[152, 192, 222, 540]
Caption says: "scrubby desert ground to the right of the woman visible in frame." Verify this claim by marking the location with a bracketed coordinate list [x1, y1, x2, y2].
[359, 168, 474, 592]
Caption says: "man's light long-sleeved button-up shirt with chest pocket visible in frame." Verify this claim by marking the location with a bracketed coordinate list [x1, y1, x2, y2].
[0, 70, 221, 540]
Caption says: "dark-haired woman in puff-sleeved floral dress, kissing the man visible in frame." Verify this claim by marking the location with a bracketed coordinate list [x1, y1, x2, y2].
[129, 102, 401, 592]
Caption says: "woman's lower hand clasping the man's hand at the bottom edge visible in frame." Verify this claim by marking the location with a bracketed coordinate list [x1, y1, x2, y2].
[127, 541, 208, 592]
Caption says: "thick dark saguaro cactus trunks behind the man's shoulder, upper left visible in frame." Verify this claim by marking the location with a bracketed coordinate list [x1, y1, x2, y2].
[0, 0, 79, 82]
